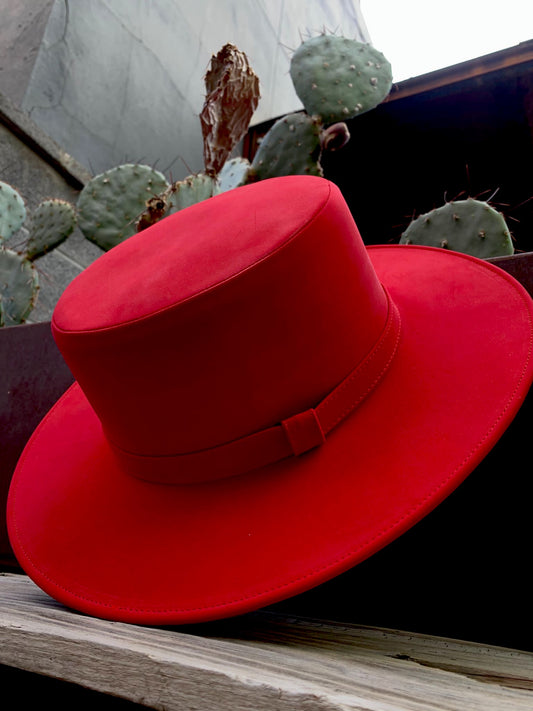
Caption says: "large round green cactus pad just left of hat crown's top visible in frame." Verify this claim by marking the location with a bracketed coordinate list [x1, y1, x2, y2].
[78, 163, 169, 250]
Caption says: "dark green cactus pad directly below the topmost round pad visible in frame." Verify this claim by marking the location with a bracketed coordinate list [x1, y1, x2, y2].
[248, 113, 323, 182]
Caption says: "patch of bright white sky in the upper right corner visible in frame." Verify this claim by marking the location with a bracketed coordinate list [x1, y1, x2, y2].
[361, 0, 533, 81]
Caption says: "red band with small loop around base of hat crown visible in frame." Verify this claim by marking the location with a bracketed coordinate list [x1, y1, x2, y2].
[110, 290, 401, 484]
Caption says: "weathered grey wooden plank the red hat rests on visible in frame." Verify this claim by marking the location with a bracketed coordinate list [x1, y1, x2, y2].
[0, 574, 533, 711]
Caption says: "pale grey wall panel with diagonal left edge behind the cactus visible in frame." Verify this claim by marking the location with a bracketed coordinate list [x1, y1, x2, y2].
[21, 0, 368, 179]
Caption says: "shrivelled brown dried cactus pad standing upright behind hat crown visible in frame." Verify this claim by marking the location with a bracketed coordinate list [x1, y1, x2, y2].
[200, 43, 260, 175]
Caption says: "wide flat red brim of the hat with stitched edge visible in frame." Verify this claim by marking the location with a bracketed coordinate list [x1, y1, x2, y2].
[8, 246, 533, 624]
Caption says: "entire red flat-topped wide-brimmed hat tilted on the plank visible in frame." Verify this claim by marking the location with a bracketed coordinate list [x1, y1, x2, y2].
[8, 176, 533, 624]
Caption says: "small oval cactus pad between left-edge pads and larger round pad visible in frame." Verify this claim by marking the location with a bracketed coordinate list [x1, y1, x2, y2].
[26, 199, 77, 259]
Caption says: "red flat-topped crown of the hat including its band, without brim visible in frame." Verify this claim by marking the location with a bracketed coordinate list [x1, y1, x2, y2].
[53, 181, 394, 483]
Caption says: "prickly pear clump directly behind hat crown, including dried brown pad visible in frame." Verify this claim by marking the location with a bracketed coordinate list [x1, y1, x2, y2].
[78, 35, 391, 245]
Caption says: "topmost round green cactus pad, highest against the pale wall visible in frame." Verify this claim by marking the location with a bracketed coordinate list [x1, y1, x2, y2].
[290, 34, 392, 123]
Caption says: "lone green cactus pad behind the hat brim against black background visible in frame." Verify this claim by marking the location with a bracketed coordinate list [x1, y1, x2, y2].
[400, 198, 514, 259]
